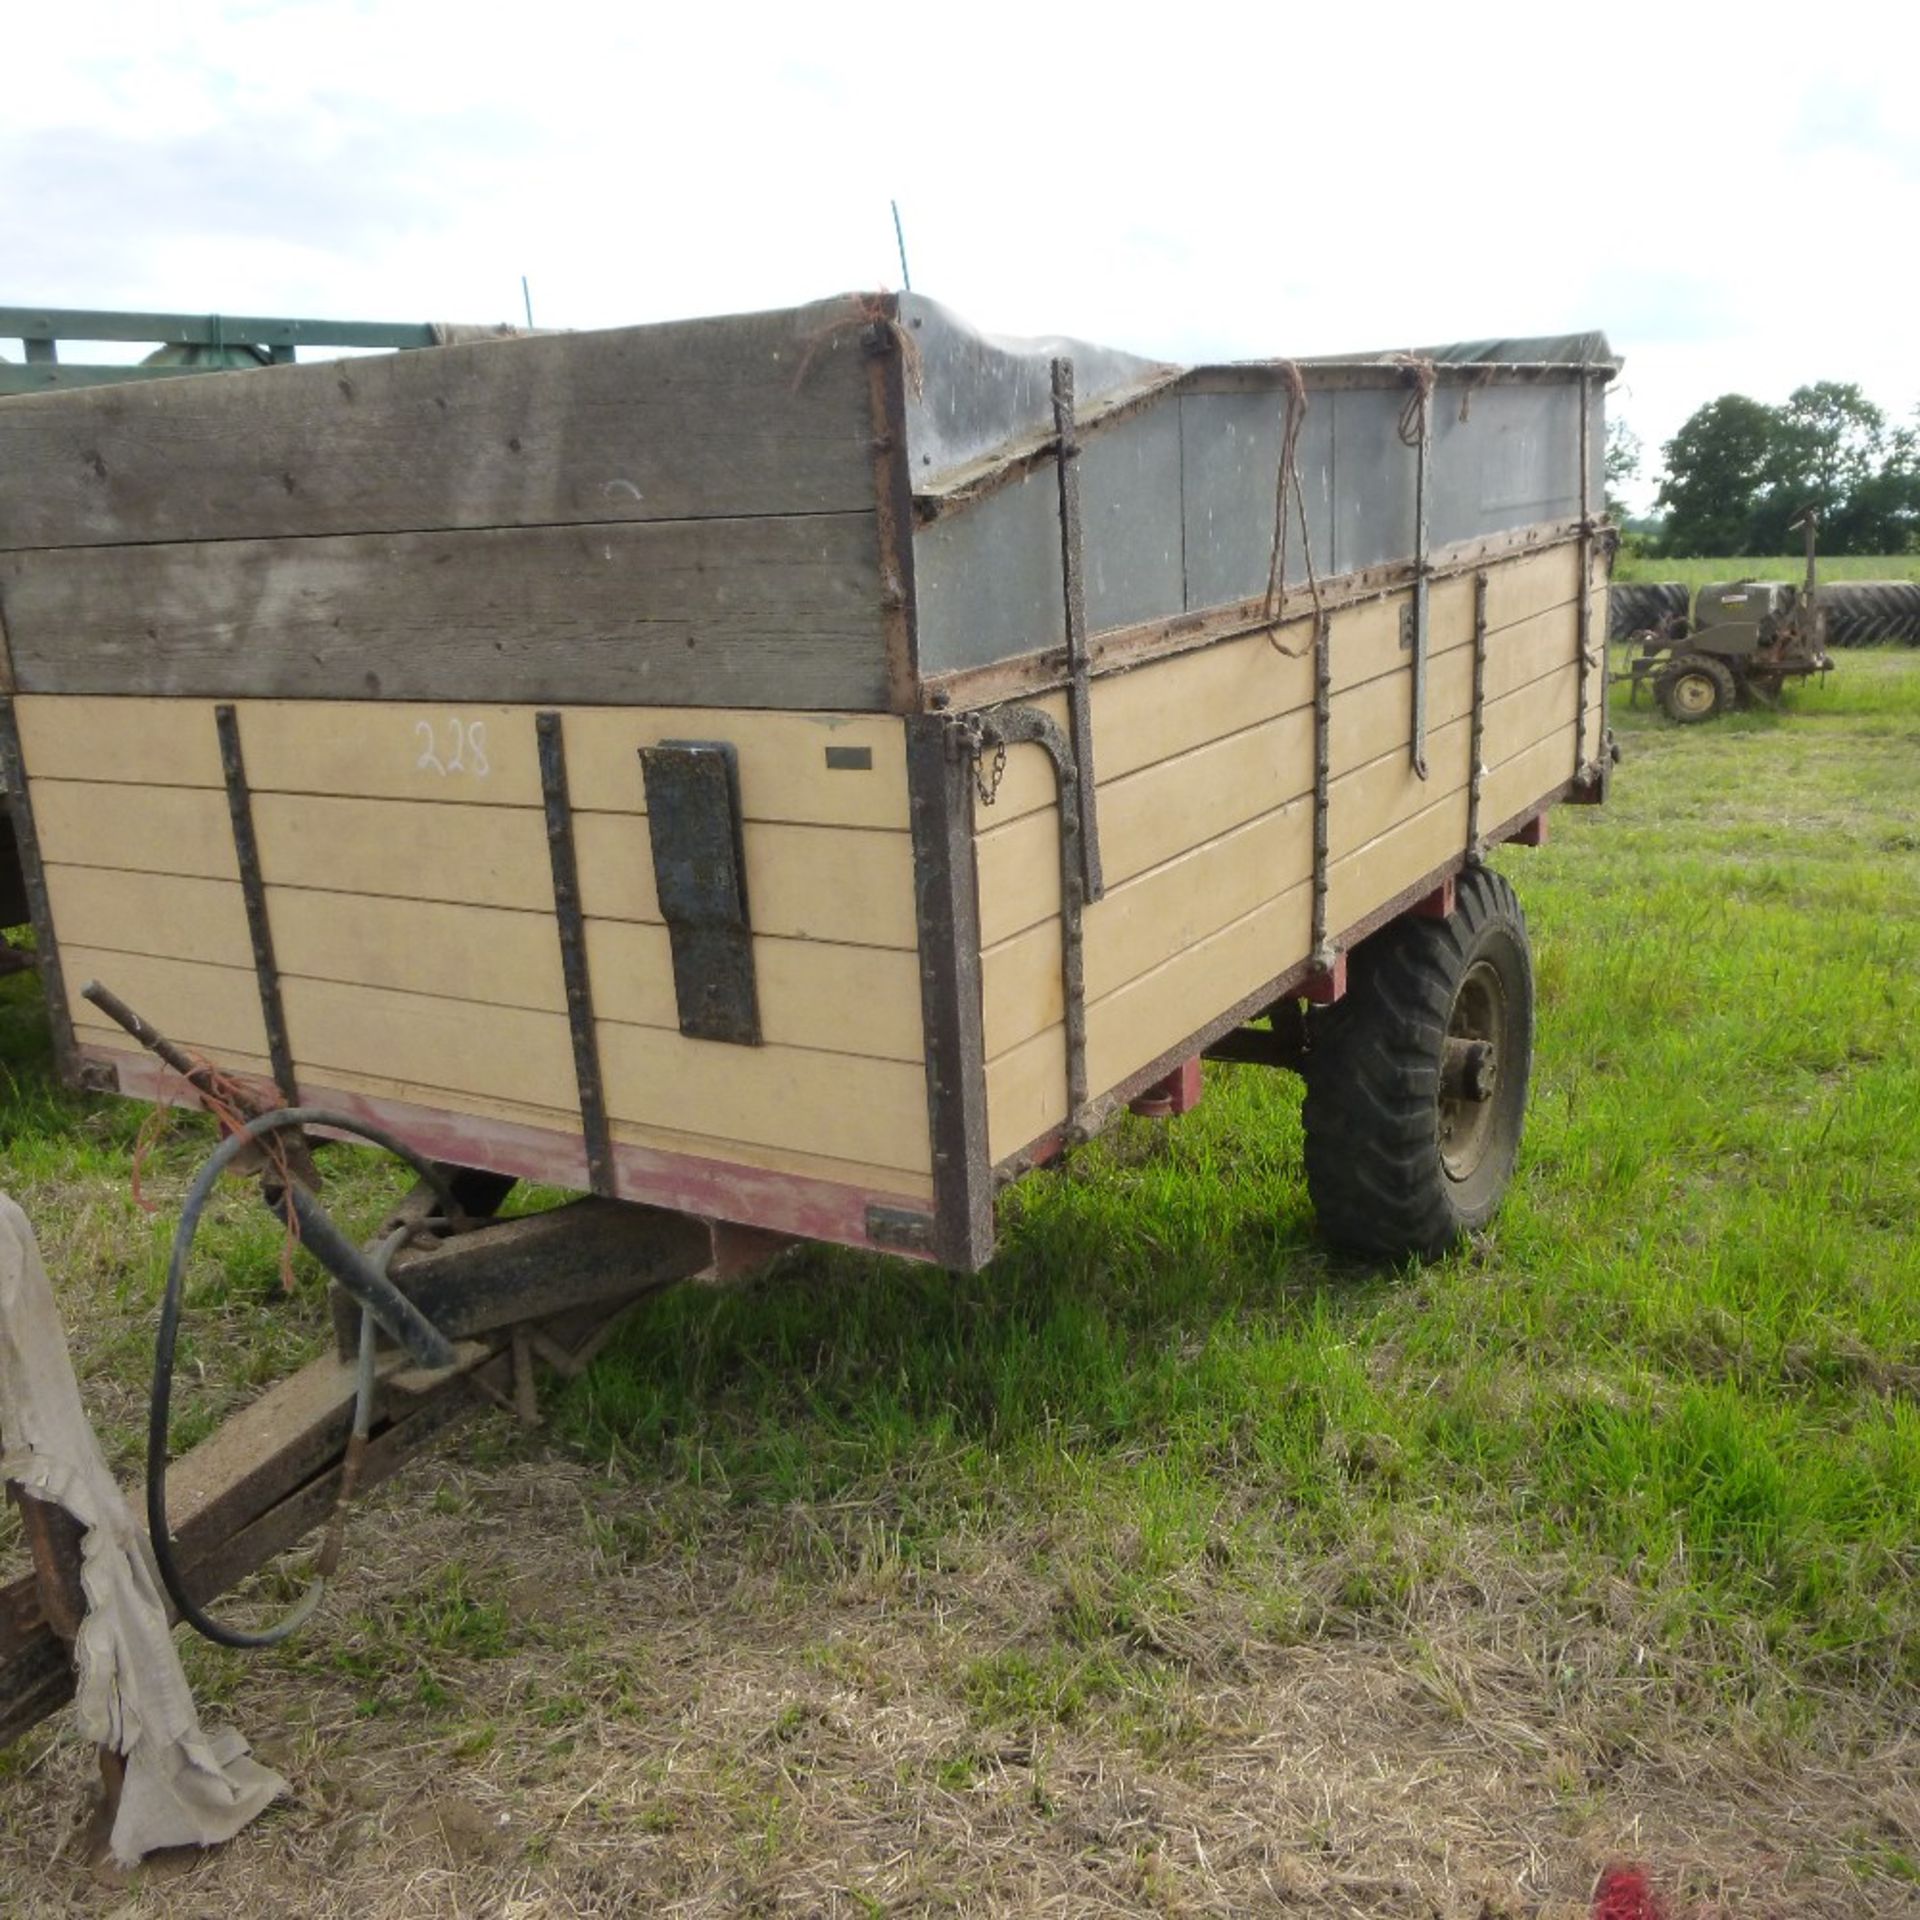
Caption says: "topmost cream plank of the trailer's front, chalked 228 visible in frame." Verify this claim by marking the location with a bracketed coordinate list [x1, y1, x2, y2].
[17, 693, 906, 829]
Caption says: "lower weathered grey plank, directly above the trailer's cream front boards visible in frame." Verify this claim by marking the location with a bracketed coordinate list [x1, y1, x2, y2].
[0, 510, 887, 708]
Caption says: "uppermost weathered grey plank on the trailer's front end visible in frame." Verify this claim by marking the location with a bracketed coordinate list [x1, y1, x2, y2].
[0, 300, 874, 547]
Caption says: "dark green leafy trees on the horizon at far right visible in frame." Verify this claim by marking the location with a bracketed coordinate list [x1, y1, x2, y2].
[1635, 380, 1920, 559]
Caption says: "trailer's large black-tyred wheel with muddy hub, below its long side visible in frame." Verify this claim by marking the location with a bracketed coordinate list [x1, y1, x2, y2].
[1302, 868, 1534, 1260]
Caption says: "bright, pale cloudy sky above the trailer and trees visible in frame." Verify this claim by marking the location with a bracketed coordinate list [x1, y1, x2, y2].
[0, 0, 1920, 507]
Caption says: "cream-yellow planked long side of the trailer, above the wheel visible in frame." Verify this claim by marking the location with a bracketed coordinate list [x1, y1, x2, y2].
[973, 545, 1605, 1160]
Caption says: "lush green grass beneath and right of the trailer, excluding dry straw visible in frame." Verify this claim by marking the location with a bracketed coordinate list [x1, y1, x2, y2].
[537, 655, 1920, 1716]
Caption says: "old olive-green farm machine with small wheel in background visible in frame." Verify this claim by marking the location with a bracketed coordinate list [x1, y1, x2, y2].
[1624, 507, 1834, 726]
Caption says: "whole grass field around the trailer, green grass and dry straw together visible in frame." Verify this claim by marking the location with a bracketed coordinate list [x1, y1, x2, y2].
[0, 656, 1920, 1920]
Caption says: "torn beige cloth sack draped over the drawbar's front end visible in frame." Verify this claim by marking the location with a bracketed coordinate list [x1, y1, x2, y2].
[0, 1194, 286, 1866]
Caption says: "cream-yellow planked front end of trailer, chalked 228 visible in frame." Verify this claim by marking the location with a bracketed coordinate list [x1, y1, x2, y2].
[19, 695, 931, 1194]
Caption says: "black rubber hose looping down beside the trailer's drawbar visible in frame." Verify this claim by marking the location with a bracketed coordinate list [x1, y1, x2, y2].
[146, 1106, 457, 1647]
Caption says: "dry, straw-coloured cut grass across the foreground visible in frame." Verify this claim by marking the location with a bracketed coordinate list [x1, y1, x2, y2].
[0, 1453, 1920, 1920]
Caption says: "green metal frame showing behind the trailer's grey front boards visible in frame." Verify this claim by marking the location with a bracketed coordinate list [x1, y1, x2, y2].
[0, 307, 434, 396]
